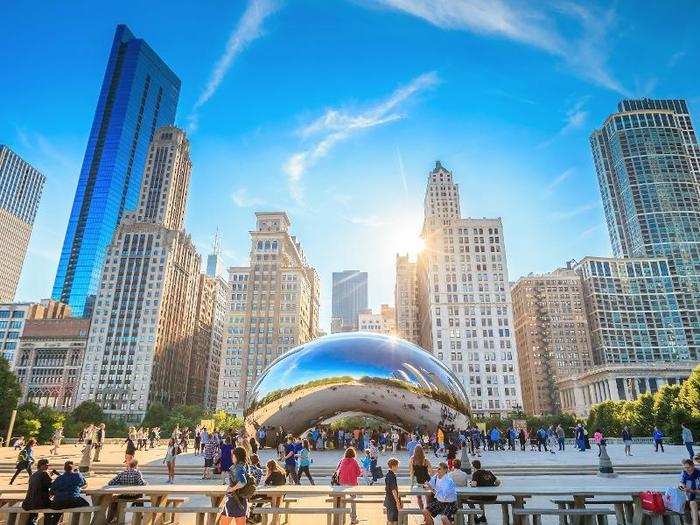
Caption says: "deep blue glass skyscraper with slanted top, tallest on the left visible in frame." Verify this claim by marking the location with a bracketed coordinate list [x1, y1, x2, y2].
[52, 25, 180, 316]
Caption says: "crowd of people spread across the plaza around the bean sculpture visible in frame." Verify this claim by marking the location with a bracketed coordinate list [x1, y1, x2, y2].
[4, 424, 700, 525]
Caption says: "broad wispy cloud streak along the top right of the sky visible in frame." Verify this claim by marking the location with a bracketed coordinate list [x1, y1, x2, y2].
[374, 0, 627, 94]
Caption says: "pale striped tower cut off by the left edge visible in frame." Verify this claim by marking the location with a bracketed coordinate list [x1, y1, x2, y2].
[0, 144, 46, 302]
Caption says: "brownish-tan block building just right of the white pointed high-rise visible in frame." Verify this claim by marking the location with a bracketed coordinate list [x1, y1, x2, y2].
[511, 268, 593, 414]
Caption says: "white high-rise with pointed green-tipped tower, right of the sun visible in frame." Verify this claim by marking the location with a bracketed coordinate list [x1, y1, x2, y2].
[418, 161, 522, 414]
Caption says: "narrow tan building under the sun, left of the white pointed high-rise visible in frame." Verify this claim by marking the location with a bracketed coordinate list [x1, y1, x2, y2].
[394, 254, 420, 345]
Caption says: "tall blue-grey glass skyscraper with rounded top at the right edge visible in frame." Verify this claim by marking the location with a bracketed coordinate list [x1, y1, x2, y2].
[590, 99, 700, 360]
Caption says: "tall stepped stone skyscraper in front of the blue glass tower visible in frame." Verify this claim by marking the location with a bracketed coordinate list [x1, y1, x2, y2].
[77, 126, 201, 421]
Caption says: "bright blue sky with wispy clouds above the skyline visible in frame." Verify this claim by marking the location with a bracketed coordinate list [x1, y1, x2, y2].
[0, 0, 700, 328]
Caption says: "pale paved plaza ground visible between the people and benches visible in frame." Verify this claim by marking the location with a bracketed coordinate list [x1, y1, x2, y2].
[0, 444, 686, 525]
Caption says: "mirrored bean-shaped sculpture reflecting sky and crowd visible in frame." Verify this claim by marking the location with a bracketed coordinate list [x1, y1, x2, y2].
[245, 332, 469, 434]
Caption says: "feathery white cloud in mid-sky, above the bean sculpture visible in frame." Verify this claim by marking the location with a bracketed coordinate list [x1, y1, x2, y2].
[282, 71, 439, 203]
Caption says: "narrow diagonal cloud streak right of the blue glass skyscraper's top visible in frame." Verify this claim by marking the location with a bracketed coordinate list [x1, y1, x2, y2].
[187, 0, 278, 131]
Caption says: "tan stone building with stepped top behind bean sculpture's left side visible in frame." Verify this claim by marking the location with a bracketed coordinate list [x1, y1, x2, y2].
[217, 212, 319, 412]
